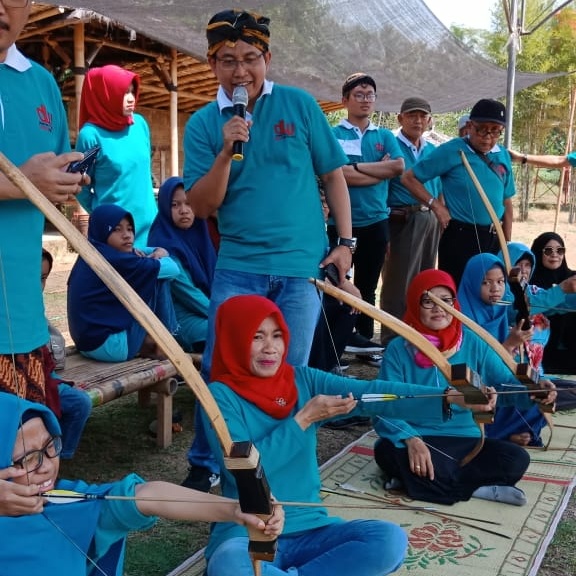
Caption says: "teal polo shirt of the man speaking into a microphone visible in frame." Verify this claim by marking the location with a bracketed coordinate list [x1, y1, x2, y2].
[184, 82, 347, 278]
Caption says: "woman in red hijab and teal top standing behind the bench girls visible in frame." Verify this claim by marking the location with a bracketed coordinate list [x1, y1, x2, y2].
[76, 65, 158, 248]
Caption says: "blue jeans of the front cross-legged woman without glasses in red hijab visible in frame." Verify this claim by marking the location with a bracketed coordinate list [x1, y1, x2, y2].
[207, 520, 408, 576]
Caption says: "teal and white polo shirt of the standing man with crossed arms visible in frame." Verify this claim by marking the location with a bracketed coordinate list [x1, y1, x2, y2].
[333, 120, 402, 227]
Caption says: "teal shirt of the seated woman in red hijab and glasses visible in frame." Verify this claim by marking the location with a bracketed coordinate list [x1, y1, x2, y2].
[374, 327, 532, 448]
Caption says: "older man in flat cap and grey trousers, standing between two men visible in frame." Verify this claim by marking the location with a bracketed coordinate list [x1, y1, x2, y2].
[380, 97, 442, 346]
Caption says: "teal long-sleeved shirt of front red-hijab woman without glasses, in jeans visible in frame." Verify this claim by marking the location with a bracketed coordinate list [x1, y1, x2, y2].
[202, 367, 462, 558]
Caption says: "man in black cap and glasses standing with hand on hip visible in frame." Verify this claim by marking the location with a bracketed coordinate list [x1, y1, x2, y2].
[402, 99, 516, 283]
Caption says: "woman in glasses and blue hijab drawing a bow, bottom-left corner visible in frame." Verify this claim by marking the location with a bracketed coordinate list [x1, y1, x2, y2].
[0, 393, 283, 576]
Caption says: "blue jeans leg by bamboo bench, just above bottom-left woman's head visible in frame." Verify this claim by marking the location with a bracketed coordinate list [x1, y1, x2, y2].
[58, 383, 92, 459]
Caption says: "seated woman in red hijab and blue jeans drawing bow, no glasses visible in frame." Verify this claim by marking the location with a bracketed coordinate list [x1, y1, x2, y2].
[200, 296, 492, 576]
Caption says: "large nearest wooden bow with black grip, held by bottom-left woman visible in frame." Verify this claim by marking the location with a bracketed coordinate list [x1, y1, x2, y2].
[0, 153, 276, 576]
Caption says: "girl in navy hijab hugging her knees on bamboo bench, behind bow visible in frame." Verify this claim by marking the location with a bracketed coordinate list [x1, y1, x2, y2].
[68, 204, 179, 362]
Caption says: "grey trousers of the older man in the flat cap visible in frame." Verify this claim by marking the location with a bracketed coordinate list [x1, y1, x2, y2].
[380, 210, 441, 345]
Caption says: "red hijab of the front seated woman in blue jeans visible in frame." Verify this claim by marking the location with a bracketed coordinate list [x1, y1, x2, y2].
[210, 295, 298, 419]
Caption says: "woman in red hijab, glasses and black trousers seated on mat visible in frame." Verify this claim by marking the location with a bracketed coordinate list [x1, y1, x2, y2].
[374, 270, 530, 506]
